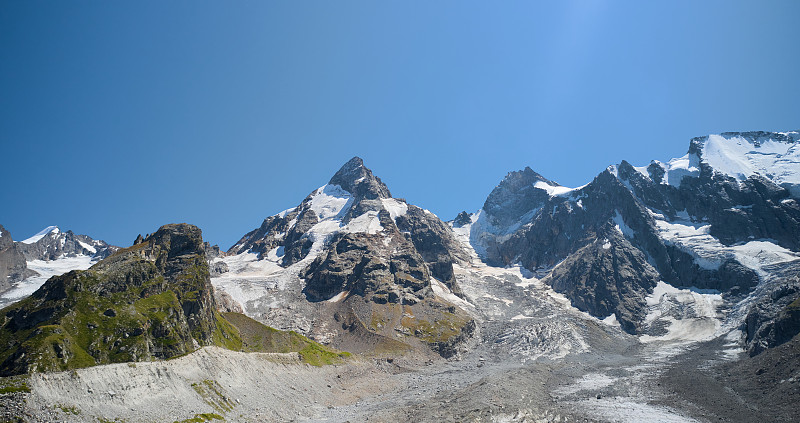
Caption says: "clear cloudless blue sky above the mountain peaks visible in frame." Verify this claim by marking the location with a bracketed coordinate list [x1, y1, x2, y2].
[0, 0, 800, 249]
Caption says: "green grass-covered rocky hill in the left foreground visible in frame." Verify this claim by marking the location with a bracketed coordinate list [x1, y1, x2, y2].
[0, 224, 336, 376]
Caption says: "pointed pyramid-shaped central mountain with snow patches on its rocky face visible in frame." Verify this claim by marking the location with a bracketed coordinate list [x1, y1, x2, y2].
[212, 157, 474, 355]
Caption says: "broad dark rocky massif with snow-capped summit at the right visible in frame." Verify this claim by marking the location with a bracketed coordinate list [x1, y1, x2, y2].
[459, 132, 800, 334]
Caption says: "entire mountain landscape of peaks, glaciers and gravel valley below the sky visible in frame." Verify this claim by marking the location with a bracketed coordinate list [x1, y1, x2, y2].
[0, 132, 800, 422]
